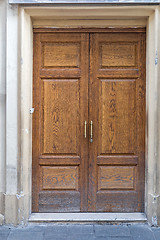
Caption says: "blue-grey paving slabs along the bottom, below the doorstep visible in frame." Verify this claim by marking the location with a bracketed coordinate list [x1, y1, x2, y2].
[0, 224, 160, 240]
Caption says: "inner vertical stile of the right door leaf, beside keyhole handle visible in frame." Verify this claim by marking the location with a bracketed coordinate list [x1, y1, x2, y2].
[88, 33, 99, 212]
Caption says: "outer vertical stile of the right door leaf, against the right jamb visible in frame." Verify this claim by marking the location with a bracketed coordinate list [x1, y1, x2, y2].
[136, 33, 146, 212]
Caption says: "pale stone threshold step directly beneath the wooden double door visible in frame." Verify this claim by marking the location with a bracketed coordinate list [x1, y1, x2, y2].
[29, 213, 147, 224]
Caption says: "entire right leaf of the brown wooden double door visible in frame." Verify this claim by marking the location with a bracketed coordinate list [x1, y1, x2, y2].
[88, 33, 145, 212]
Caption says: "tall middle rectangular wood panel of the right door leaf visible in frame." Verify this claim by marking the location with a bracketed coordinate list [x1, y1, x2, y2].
[99, 79, 136, 154]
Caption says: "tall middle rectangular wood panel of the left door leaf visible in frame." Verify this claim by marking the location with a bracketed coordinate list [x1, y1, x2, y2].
[42, 79, 80, 154]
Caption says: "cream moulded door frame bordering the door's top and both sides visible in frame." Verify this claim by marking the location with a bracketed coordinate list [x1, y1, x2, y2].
[17, 6, 160, 225]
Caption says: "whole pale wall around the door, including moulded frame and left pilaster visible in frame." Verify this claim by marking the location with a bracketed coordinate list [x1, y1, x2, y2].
[0, 0, 160, 225]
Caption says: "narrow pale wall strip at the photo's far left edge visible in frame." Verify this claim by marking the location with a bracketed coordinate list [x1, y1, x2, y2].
[0, 0, 6, 224]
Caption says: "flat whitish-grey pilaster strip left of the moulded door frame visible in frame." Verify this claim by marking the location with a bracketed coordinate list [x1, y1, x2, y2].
[5, 4, 20, 224]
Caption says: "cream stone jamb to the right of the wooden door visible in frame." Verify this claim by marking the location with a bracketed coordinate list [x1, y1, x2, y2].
[146, 8, 160, 225]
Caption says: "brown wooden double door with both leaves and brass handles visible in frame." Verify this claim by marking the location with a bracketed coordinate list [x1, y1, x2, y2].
[32, 29, 145, 212]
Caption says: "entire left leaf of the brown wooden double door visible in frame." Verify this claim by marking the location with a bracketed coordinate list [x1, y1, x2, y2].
[33, 33, 89, 212]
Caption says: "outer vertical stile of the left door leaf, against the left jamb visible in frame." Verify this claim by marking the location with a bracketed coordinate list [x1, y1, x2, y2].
[32, 34, 41, 212]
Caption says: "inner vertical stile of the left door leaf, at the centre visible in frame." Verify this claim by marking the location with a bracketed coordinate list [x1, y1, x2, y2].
[80, 33, 89, 212]
